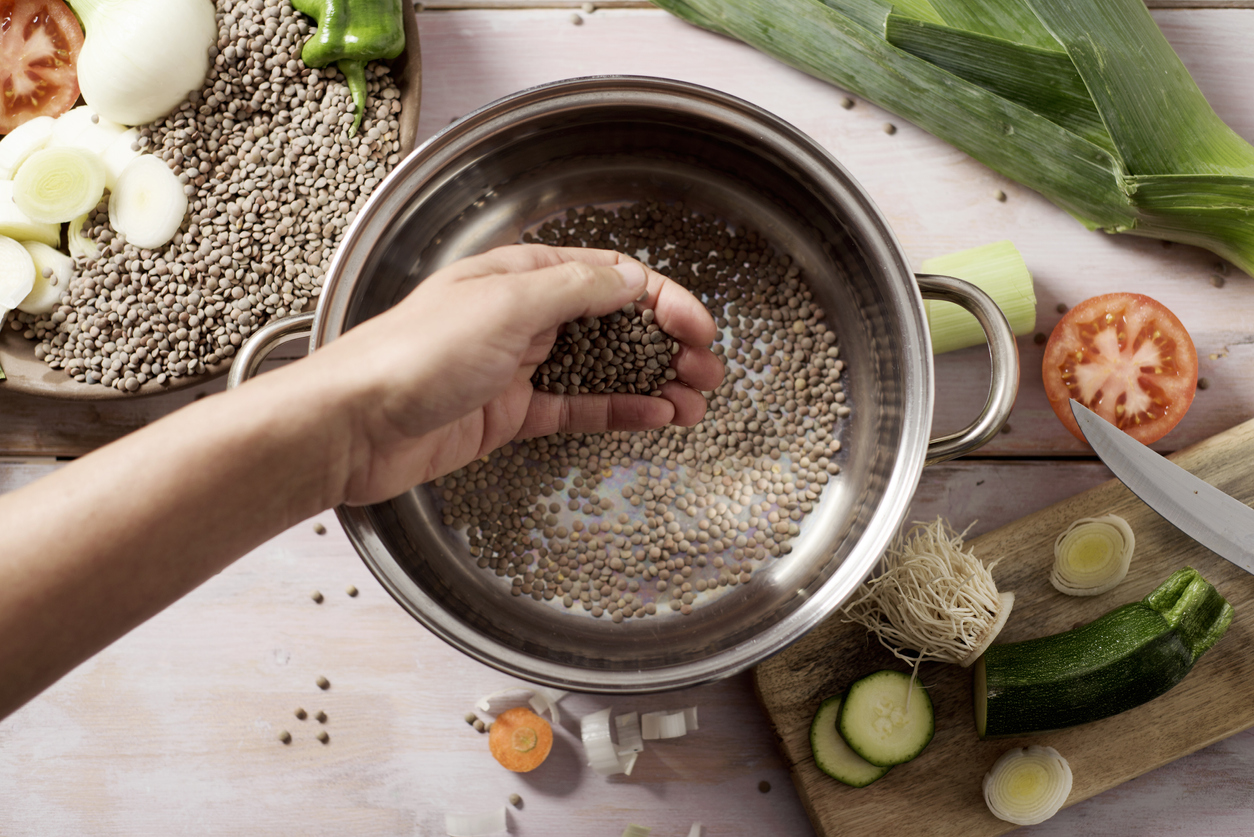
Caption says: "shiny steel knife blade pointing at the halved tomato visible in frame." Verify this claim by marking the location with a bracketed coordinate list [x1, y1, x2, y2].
[1071, 399, 1254, 573]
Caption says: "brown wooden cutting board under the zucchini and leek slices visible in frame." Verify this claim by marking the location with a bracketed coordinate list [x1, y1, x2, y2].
[754, 420, 1254, 837]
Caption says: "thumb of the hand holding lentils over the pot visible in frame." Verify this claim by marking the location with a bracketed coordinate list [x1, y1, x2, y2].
[499, 256, 648, 333]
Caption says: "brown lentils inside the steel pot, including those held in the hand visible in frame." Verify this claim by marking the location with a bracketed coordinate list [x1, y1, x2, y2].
[434, 201, 851, 622]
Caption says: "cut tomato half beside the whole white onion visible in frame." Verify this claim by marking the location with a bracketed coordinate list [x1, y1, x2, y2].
[0, 0, 83, 134]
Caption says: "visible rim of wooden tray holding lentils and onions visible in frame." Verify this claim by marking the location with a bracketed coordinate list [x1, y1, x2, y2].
[0, 3, 423, 402]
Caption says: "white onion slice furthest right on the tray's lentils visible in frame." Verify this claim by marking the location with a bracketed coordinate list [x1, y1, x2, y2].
[107, 154, 187, 250]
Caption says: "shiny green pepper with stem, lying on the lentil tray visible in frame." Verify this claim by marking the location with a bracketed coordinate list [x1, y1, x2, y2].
[292, 0, 406, 137]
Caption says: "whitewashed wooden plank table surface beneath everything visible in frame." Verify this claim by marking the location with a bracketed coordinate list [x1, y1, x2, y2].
[0, 0, 1254, 837]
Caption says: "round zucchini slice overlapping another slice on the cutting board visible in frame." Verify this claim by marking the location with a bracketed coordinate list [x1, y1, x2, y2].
[836, 669, 935, 767]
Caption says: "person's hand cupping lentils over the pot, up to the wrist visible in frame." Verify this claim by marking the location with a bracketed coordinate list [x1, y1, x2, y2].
[302, 245, 724, 504]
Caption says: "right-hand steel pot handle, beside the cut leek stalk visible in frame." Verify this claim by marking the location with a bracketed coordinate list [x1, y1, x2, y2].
[917, 274, 1020, 466]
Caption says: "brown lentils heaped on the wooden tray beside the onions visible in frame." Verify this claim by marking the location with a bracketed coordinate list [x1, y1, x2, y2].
[11, 0, 400, 392]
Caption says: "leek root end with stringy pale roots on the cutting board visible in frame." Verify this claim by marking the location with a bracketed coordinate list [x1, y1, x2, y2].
[837, 517, 1014, 667]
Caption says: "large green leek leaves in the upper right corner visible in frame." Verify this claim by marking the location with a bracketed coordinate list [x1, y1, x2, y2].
[655, 0, 1254, 274]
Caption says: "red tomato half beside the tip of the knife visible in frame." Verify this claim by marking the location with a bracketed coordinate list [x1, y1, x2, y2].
[1041, 294, 1198, 444]
